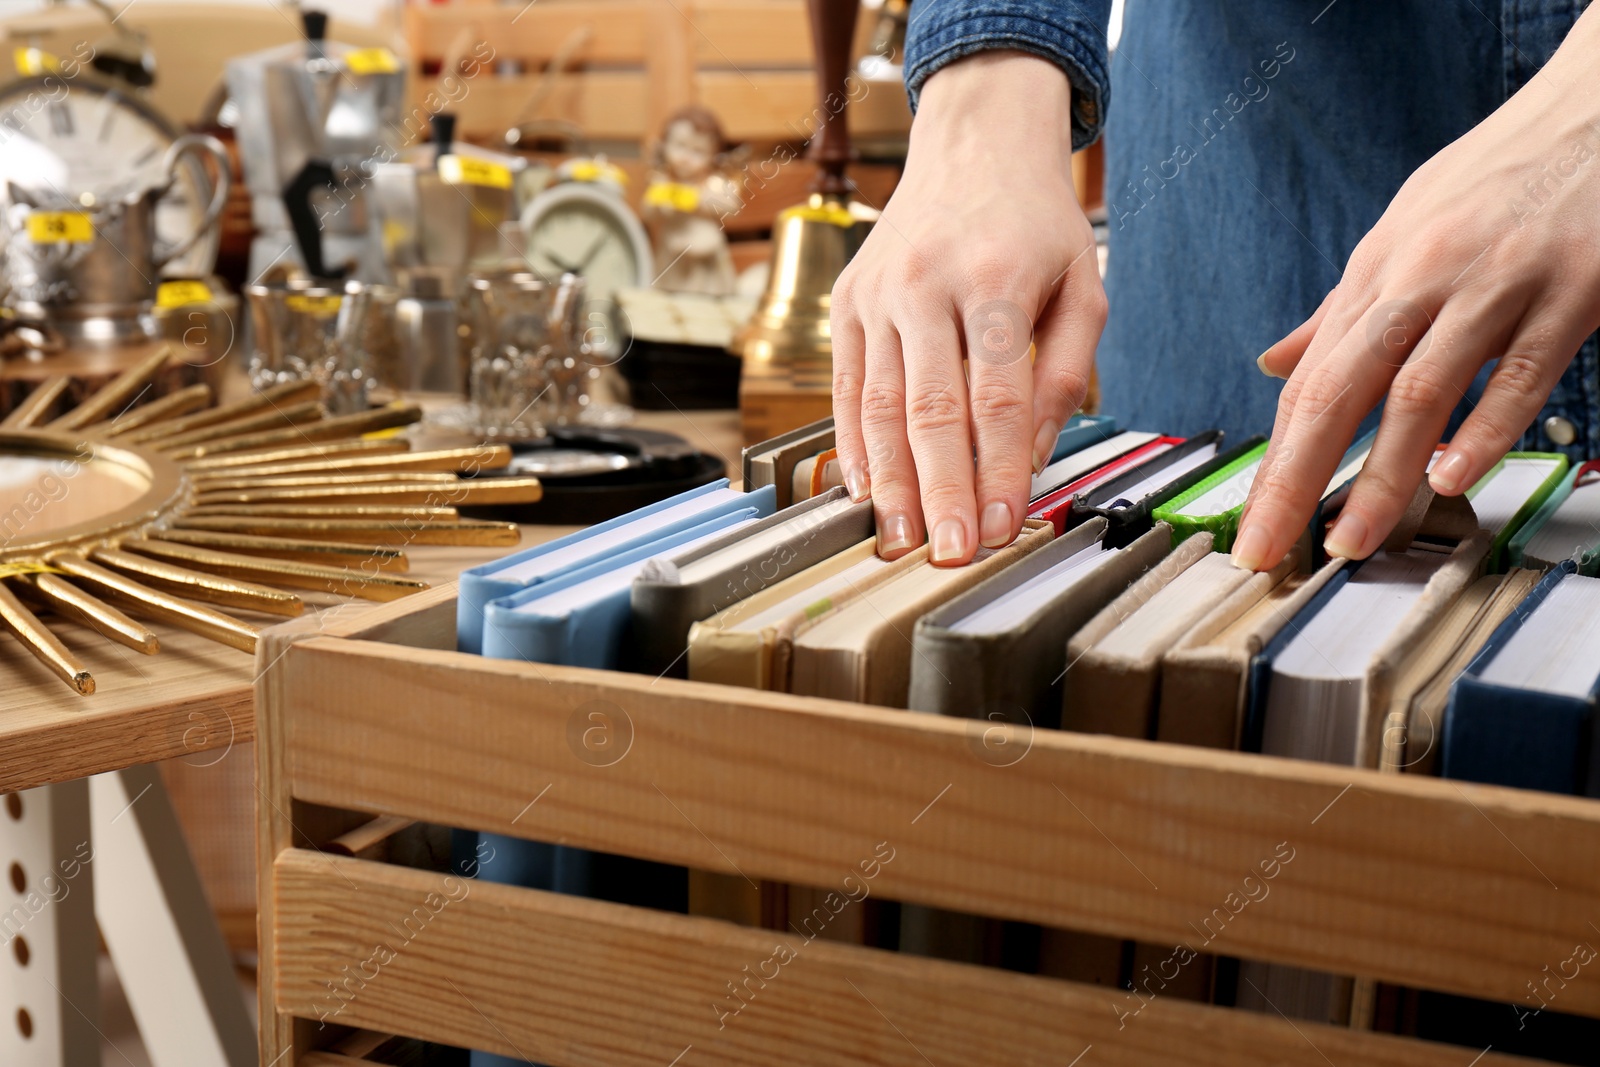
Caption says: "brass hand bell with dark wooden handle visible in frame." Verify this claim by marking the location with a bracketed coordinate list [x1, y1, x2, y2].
[731, 0, 877, 381]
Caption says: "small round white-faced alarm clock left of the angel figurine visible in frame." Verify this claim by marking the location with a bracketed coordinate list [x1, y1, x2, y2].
[522, 181, 654, 357]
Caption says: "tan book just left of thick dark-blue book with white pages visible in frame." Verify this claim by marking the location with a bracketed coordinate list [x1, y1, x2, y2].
[1155, 549, 1339, 749]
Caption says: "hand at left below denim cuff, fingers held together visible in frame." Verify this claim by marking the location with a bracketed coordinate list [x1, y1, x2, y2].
[832, 53, 1106, 565]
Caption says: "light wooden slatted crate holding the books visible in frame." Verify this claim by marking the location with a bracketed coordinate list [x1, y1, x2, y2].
[256, 587, 1600, 1067]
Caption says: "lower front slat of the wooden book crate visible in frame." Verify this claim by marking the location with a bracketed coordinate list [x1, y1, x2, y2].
[272, 849, 1548, 1067]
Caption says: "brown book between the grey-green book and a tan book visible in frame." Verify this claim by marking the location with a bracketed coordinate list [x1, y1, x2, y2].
[1061, 533, 1251, 737]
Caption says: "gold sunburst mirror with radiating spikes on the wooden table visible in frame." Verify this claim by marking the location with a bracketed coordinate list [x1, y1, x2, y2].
[0, 349, 539, 694]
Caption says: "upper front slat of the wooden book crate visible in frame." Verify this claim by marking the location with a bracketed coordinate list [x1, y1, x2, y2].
[278, 633, 1600, 1016]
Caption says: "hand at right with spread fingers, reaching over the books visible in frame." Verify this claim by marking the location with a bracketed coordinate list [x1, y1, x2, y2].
[1234, 13, 1600, 569]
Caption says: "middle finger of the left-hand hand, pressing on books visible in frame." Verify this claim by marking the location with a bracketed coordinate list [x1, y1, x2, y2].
[899, 309, 978, 566]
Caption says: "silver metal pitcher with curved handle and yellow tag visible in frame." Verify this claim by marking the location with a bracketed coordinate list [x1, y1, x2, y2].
[5, 134, 229, 341]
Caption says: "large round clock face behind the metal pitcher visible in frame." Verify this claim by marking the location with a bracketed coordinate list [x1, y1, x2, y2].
[0, 77, 221, 277]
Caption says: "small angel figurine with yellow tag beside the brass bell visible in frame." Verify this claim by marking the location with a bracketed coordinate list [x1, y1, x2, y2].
[642, 107, 744, 296]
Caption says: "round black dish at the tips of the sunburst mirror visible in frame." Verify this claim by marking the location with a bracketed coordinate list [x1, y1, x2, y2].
[461, 427, 726, 526]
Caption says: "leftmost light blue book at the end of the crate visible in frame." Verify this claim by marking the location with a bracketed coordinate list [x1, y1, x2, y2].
[456, 478, 778, 653]
